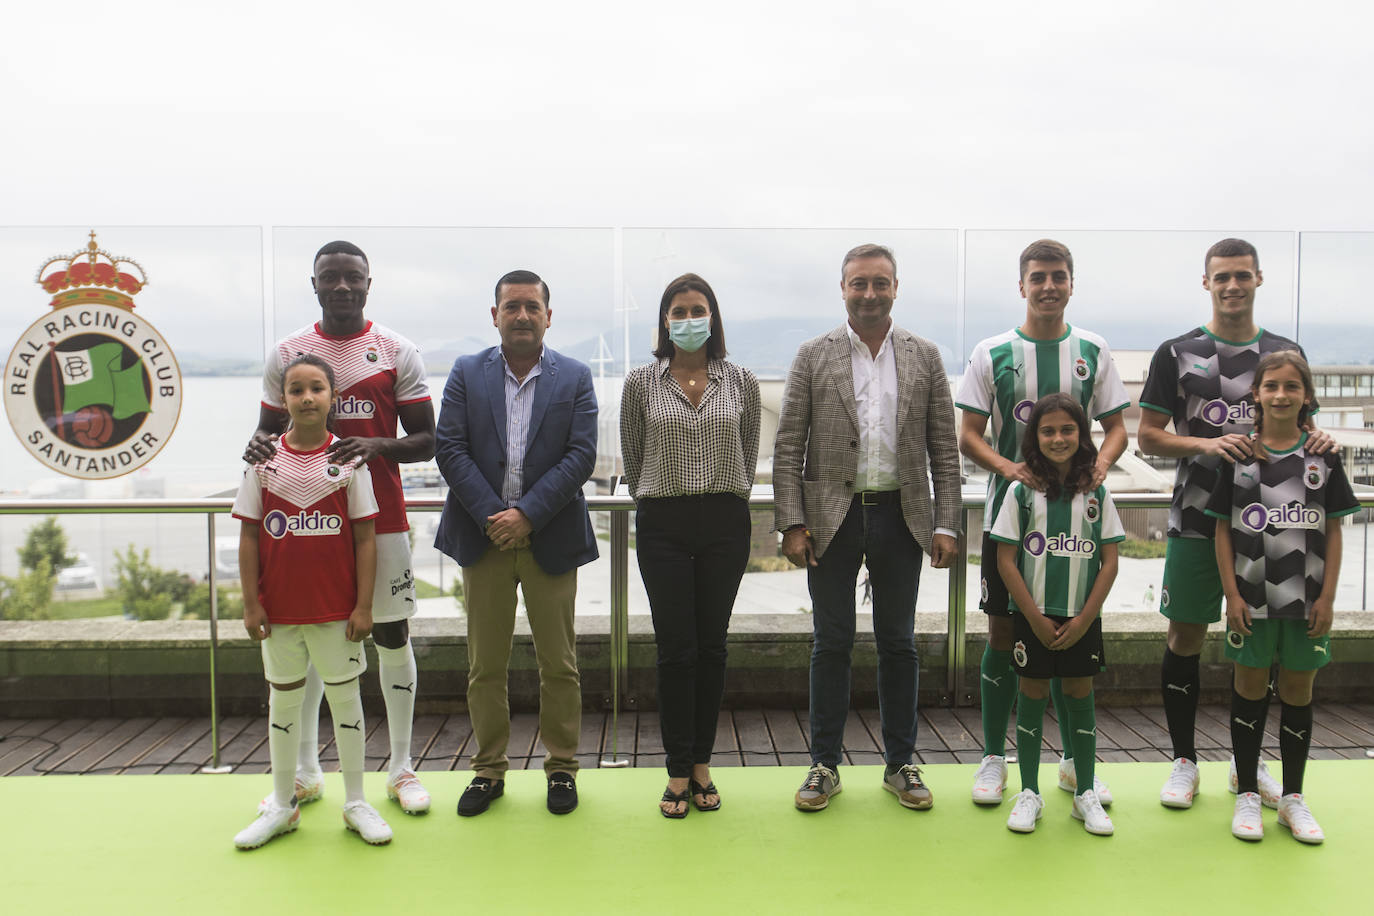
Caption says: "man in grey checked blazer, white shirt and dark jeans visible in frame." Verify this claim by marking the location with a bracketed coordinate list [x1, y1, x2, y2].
[774, 244, 960, 810]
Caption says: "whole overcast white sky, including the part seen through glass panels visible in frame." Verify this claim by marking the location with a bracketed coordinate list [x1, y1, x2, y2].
[0, 0, 1374, 376]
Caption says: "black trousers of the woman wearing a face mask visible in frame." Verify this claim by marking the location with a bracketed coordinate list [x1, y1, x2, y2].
[635, 493, 749, 776]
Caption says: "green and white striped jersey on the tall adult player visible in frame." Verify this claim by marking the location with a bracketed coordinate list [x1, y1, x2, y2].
[955, 325, 1131, 531]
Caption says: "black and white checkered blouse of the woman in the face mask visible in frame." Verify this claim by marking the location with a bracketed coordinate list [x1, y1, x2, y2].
[620, 357, 758, 500]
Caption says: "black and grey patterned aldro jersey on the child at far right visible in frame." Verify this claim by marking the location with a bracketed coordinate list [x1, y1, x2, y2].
[1206, 433, 1360, 619]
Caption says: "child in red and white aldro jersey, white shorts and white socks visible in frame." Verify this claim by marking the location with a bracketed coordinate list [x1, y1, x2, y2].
[234, 354, 392, 849]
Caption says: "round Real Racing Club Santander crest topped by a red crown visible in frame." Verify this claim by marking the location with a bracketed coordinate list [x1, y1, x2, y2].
[4, 232, 181, 481]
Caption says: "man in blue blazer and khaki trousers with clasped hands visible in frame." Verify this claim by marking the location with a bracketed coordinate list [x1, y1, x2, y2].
[434, 271, 598, 816]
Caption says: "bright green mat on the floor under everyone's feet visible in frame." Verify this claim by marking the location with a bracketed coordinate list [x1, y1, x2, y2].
[0, 761, 1374, 916]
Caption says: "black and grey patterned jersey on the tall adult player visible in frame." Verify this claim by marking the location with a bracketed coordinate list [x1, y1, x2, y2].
[1140, 327, 1307, 537]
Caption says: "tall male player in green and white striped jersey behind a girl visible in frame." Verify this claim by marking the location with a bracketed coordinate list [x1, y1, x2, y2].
[955, 239, 1131, 805]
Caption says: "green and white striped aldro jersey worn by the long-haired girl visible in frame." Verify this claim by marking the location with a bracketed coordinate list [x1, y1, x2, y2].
[982, 483, 1125, 617]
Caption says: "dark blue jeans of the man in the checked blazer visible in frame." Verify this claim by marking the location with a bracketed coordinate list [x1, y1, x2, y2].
[807, 492, 922, 768]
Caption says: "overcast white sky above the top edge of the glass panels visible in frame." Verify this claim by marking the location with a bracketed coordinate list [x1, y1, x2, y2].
[0, 0, 1374, 229]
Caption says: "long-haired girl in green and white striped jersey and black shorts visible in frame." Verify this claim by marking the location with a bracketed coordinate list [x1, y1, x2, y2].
[992, 393, 1125, 836]
